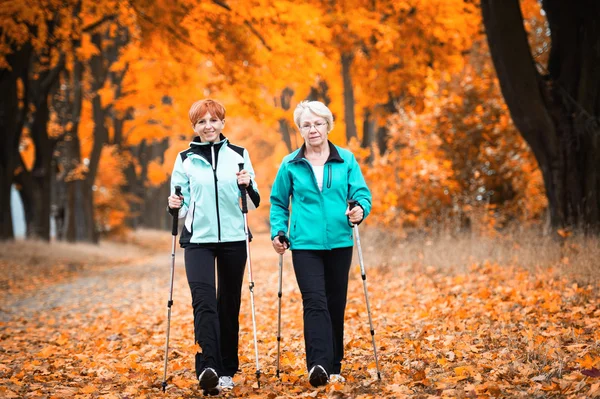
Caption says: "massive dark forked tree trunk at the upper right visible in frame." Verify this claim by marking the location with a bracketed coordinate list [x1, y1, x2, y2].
[481, 0, 600, 233]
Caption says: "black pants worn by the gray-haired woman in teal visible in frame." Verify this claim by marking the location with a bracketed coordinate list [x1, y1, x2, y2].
[292, 247, 352, 374]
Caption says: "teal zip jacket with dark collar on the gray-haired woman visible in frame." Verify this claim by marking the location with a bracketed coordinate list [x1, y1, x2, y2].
[270, 142, 371, 250]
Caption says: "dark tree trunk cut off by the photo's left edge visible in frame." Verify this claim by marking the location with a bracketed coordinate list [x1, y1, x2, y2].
[0, 44, 32, 240]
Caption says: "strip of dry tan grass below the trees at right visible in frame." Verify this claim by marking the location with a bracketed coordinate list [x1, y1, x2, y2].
[361, 227, 600, 288]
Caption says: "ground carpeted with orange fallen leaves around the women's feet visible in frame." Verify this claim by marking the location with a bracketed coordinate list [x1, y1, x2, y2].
[0, 234, 600, 399]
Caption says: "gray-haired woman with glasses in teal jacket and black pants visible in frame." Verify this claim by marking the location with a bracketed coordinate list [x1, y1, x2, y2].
[270, 101, 371, 387]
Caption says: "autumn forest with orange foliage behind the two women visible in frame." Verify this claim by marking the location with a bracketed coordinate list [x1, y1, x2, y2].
[0, 0, 599, 242]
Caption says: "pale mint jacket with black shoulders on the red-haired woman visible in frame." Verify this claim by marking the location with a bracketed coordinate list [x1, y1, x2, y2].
[171, 135, 260, 247]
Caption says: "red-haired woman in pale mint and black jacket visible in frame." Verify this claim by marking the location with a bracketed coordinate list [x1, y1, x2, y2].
[168, 99, 260, 393]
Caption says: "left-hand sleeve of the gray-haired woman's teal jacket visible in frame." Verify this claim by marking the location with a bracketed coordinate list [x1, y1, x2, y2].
[269, 160, 292, 240]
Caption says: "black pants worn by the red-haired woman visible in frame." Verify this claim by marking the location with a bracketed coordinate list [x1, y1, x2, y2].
[185, 241, 246, 377]
